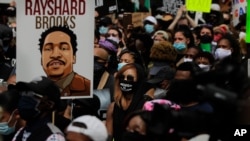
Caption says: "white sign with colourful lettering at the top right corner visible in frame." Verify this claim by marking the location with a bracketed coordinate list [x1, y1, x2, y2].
[232, 0, 247, 26]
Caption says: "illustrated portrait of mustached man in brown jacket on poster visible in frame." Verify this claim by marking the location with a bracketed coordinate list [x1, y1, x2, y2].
[39, 25, 91, 97]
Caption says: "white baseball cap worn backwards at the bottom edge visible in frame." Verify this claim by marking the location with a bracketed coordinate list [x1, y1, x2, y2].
[66, 115, 108, 141]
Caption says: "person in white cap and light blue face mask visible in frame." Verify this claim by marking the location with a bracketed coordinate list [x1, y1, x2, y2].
[143, 16, 158, 36]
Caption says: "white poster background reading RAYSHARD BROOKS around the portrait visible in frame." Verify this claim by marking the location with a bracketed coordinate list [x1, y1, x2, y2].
[16, 0, 95, 99]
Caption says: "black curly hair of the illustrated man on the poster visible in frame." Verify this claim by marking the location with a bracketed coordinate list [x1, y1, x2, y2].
[39, 26, 77, 55]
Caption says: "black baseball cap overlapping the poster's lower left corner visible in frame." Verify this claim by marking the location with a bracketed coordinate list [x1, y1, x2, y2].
[8, 76, 61, 110]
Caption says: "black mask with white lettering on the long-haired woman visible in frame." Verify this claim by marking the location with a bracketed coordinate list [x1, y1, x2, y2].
[120, 80, 136, 94]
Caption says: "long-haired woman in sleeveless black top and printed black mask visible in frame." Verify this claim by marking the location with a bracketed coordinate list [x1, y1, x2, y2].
[106, 63, 154, 141]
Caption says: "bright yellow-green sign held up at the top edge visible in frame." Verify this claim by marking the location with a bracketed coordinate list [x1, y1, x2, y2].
[186, 0, 212, 13]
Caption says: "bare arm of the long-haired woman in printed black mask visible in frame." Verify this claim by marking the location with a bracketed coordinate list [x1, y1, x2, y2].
[106, 102, 115, 141]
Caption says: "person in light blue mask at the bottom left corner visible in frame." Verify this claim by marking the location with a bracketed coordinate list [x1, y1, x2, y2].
[0, 90, 25, 141]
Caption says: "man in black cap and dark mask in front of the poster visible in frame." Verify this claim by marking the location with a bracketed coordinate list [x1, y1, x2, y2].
[12, 76, 65, 141]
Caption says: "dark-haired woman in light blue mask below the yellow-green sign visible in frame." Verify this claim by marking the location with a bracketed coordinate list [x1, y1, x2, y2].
[173, 25, 194, 63]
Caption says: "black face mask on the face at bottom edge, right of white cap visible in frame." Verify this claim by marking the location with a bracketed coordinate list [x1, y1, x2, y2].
[122, 131, 149, 141]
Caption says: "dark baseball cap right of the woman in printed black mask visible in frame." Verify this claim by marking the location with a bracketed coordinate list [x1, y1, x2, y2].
[148, 66, 175, 84]
